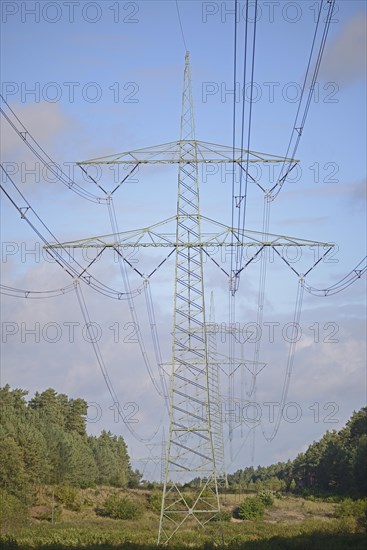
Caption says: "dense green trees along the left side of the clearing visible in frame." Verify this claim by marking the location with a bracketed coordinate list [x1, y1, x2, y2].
[0, 385, 141, 500]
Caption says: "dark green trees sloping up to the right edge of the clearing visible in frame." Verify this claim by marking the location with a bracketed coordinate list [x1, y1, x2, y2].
[228, 407, 367, 496]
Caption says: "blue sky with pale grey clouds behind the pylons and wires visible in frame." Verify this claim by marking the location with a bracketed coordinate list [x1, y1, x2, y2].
[1, 0, 366, 478]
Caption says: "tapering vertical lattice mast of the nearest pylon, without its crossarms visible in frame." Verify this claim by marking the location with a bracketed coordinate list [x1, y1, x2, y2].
[158, 53, 220, 542]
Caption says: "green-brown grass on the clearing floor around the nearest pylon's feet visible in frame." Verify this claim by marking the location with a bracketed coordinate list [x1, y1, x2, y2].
[0, 488, 367, 550]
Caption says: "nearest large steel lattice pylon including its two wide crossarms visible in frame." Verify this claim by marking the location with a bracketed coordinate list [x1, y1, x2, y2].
[47, 52, 332, 543]
